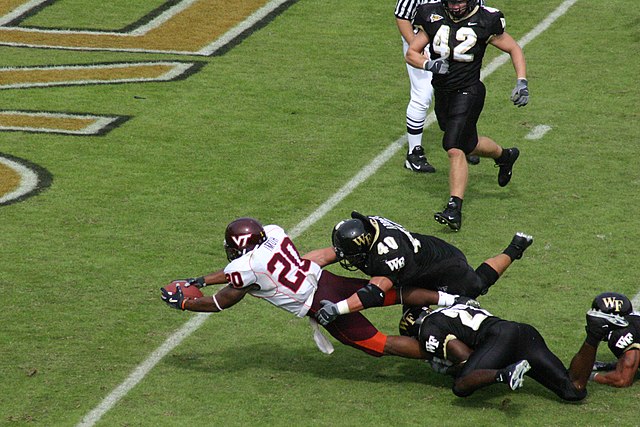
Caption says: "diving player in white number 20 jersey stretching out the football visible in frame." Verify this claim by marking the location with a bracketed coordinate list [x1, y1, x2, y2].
[162, 218, 468, 358]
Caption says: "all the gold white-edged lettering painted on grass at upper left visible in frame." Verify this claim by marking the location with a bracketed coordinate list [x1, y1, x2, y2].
[0, 0, 296, 206]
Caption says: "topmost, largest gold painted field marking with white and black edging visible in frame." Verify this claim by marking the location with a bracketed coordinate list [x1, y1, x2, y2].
[0, 0, 296, 56]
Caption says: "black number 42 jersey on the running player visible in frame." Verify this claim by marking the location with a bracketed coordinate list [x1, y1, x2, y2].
[413, 2, 506, 91]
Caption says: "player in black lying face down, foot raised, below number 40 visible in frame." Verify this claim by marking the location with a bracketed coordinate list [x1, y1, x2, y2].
[400, 298, 626, 401]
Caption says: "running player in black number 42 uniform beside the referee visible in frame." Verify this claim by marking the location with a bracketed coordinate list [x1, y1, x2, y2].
[405, 0, 529, 231]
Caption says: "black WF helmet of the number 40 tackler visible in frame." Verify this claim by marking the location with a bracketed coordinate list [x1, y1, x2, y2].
[331, 212, 375, 271]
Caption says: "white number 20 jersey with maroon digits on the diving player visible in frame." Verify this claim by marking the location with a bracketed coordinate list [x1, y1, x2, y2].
[224, 225, 322, 317]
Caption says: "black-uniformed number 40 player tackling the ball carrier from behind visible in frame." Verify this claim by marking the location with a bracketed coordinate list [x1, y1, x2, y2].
[306, 212, 533, 325]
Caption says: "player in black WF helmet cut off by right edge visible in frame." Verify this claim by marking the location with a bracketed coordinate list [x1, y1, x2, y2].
[583, 292, 640, 387]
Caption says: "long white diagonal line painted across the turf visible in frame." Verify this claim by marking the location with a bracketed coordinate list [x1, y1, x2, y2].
[78, 0, 578, 427]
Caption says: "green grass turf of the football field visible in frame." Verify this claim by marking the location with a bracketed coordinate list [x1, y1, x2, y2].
[0, 0, 640, 426]
